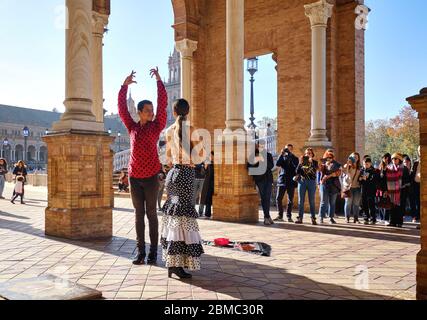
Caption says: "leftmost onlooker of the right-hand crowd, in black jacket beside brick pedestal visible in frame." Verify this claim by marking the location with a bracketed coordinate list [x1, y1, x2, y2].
[248, 145, 274, 225]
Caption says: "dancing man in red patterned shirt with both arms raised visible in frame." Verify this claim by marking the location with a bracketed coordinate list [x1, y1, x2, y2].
[119, 68, 168, 264]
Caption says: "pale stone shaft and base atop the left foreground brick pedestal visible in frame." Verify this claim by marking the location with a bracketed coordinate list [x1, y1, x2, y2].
[53, 0, 104, 131]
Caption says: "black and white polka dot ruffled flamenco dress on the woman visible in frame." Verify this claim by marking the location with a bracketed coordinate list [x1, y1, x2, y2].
[160, 125, 204, 270]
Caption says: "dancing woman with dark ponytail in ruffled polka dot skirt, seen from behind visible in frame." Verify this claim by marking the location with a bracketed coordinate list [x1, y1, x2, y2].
[161, 99, 204, 278]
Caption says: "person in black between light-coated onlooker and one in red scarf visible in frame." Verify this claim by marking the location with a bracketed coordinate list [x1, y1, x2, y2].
[359, 158, 380, 224]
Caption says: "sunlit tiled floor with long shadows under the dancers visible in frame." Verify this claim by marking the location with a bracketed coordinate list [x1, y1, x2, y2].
[0, 184, 420, 300]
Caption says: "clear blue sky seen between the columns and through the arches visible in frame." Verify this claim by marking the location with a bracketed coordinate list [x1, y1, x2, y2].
[0, 0, 427, 124]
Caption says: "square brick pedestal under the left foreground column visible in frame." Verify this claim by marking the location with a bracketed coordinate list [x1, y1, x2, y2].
[43, 132, 114, 239]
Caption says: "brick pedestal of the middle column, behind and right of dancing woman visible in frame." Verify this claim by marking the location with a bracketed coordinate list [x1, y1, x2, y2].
[212, 141, 260, 223]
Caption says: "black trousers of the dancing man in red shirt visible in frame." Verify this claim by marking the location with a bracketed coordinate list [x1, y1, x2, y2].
[129, 175, 159, 253]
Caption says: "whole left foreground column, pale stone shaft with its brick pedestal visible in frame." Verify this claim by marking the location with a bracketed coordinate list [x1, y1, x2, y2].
[42, 0, 114, 239]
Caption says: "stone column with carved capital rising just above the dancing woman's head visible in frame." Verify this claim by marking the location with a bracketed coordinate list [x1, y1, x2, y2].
[174, 39, 197, 105]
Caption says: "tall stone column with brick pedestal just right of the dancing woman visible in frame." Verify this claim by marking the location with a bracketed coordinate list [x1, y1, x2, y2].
[212, 0, 259, 222]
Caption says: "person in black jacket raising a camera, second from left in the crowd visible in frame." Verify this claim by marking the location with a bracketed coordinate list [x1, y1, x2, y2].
[274, 144, 299, 222]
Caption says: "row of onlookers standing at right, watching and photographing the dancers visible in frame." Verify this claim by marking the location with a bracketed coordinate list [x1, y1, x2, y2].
[248, 144, 421, 227]
